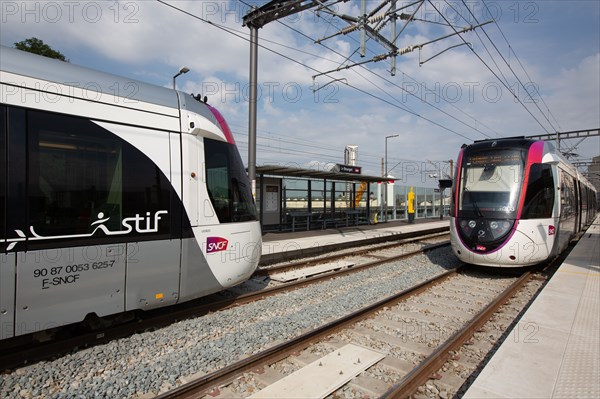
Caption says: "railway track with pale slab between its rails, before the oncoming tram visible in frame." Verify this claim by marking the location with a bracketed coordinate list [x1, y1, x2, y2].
[160, 270, 548, 399]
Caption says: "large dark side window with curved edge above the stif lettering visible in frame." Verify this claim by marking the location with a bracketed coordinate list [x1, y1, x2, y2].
[28, 111, 170, 245]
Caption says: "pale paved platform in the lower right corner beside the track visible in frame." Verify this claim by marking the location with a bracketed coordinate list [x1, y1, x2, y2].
[464, 216, 600, 398]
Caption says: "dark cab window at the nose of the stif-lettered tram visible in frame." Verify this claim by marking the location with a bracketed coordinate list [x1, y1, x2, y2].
[204, 138, 256, 223]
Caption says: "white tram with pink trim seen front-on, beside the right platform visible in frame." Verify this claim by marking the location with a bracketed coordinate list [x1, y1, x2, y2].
[450, 138, 596, 267]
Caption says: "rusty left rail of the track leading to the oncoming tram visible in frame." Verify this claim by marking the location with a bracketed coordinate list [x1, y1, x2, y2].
[157, 269, 459, 399]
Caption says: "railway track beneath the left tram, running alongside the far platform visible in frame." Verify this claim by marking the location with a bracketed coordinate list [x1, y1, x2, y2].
[0, 233, 448, 370]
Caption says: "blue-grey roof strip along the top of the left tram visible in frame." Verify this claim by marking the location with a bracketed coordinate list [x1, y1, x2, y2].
[0, 46, 179, 109]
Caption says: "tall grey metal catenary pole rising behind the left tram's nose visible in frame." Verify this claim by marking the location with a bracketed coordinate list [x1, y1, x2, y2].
[248, 25, 258, 200]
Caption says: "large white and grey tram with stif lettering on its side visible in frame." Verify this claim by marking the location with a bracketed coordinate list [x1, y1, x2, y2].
[0, 47, 262, 339]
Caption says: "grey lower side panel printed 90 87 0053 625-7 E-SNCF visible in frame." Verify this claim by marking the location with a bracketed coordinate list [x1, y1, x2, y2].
[14, 244, 126, 338]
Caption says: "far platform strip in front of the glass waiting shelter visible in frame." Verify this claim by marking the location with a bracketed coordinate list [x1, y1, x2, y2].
[260, 218, 450, 265]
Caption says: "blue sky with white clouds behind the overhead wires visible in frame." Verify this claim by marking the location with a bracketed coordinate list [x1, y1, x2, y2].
[0, 0, 600, 186]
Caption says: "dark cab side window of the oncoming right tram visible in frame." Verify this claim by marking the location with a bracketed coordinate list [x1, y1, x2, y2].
[522, 164, 554, 219]
